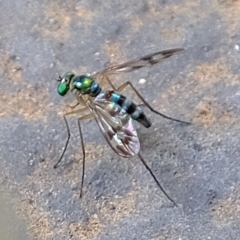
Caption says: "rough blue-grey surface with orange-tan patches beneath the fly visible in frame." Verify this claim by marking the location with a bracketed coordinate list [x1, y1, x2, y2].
[0, 0, 240, 240]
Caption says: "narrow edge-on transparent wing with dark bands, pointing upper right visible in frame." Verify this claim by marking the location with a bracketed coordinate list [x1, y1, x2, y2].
[94, 48, 184, 75]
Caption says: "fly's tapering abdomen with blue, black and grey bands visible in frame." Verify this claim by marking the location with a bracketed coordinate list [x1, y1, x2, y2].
[106, 91, 152, 128]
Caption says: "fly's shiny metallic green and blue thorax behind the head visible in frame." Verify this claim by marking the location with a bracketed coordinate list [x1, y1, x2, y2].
[72, 75, 101, 97]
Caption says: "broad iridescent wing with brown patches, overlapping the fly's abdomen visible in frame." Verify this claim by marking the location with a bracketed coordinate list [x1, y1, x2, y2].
[88, 94, 140, 158]
